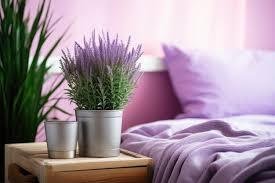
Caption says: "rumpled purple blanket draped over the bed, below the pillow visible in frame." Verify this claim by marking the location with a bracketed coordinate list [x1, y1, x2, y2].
[121, 115, 275, 183]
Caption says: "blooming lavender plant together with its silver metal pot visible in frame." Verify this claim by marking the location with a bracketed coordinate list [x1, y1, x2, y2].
[60, 31, 142, 157]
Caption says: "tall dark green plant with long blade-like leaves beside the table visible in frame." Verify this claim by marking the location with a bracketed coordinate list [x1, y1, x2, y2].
[0, 0, 67, 182]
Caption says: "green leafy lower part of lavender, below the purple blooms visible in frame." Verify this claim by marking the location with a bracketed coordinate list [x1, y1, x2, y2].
[65, 64, 135, 110]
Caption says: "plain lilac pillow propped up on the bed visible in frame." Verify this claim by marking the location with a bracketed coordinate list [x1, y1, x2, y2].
[163, 45, 275, 118]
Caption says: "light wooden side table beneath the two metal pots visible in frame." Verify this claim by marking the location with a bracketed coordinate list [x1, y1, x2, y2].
[5, 143, 152, 183]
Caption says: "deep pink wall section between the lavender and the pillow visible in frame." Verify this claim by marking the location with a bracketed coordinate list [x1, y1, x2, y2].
[123, 72, 180, 130]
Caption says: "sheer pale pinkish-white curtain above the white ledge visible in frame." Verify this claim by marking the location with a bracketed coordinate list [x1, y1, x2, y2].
[29, 0, 246, 55]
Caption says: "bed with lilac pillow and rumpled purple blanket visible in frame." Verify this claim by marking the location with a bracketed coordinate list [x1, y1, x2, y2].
[121, 46, 275, 183]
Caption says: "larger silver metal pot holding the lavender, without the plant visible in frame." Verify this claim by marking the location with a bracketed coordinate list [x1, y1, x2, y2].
[76, 110, 122, 157]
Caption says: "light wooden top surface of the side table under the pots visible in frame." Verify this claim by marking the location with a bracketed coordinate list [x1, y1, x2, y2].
[6, 142, 152, 175]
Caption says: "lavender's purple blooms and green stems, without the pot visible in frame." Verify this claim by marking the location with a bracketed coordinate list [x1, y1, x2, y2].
[60, 31, 142, 110]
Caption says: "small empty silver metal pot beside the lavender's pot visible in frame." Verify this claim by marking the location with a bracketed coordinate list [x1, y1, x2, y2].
[45, 121, 78, 159]
